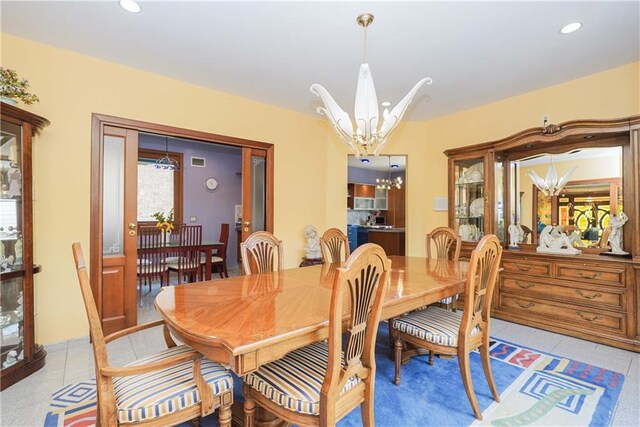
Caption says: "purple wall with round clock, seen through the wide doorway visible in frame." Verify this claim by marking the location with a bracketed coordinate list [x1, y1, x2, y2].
[139, 134, 242, 268]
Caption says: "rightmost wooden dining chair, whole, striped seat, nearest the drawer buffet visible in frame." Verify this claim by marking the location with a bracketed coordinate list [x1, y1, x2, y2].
[391, 234, 502, 420]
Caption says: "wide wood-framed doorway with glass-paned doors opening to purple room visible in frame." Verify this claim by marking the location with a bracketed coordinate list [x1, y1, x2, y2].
[90, 114, 274, 334]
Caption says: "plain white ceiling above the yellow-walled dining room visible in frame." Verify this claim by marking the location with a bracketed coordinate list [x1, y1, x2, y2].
[0, 0, 640, 120]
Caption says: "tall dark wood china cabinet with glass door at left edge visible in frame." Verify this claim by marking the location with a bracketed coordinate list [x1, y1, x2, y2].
[0, 104, 49, 389]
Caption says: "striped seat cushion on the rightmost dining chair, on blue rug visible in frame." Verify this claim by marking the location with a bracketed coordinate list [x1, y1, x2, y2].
[393, 306, 479, 347]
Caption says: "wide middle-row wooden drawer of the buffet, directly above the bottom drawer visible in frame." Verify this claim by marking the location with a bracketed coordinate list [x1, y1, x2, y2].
[500, 276, 625, 311]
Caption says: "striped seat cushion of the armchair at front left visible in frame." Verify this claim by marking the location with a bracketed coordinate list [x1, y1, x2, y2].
[113, 345, 233, 423]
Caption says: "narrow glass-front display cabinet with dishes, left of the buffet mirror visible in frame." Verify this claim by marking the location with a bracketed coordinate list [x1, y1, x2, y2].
[445, 150, 505, 244]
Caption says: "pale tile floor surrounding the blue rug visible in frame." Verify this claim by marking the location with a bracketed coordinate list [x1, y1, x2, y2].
[0, 271, 640, 426]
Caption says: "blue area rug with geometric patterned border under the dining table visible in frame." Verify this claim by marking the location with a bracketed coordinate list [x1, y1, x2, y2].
[45, 323, 624, 427]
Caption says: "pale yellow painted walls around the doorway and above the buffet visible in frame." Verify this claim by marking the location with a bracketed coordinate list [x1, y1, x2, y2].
[2, 34, 640, 344]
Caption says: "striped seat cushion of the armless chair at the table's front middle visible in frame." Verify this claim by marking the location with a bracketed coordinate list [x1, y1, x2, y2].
[244, 342, 360, 415]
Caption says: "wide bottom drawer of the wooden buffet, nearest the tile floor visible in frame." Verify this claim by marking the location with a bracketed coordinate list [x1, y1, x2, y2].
[499, 294, 626, 333]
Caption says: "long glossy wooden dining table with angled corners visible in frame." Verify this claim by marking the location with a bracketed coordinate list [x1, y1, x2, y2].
[155, 256, 468, 375]
